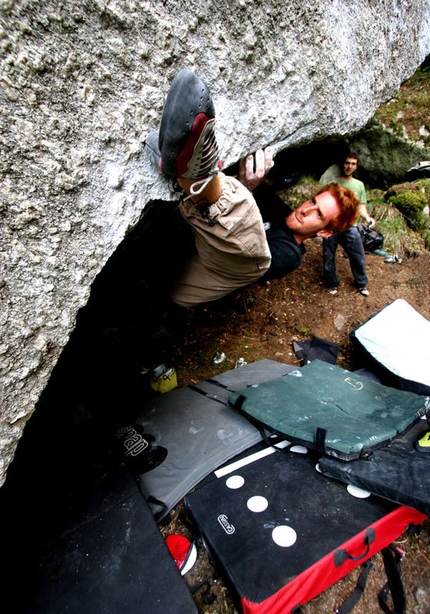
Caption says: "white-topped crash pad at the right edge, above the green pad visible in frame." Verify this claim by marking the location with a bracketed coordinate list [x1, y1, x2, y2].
[351, 299, 430, 395]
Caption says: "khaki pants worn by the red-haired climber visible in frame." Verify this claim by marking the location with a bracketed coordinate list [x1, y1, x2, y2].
[170, 173, 271, 307]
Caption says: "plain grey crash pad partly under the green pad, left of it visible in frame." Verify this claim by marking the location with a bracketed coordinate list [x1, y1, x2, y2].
[122, 360, 292, 521]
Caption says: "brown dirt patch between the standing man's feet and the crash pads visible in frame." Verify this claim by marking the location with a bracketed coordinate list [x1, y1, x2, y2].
[165, 239, 430, 386]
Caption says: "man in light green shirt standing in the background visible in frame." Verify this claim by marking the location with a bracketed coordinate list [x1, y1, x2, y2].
[323, 152, 375, 296]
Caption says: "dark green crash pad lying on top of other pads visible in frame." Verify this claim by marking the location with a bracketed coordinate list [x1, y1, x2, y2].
[229, 360, 430, 460]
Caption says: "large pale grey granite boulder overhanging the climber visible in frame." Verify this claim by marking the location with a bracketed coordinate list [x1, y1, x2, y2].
[0, 0, 430, 485]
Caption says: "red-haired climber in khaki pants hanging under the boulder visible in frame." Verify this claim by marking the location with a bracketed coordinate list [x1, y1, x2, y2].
[146, 68, 358, 307]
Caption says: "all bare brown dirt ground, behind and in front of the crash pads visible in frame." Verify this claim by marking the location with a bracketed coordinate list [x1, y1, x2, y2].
[161, 244, 430, 614]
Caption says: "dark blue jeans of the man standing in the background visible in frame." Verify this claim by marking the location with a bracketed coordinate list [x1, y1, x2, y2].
[323, 226, 368, 288]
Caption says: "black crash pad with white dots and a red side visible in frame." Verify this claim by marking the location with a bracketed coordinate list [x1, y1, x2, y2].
[185, 448, 425, 614]
